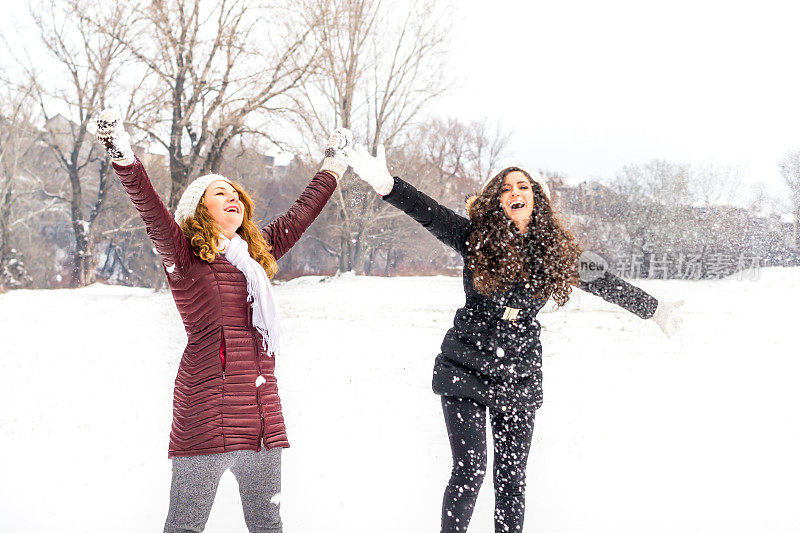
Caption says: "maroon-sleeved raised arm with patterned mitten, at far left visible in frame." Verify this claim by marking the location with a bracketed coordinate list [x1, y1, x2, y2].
[97, 110, 192, 277]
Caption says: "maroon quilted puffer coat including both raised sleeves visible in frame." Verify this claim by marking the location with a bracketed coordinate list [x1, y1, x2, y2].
[114, 160, 336, 457]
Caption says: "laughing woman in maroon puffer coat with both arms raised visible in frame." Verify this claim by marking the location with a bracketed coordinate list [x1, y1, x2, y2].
[97, 110, 352, 532]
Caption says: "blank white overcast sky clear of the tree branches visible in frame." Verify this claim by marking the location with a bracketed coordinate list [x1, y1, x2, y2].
[6, 0, 800, 196]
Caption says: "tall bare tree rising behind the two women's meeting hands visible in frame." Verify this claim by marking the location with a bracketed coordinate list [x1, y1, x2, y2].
[296, 0, 450, 271]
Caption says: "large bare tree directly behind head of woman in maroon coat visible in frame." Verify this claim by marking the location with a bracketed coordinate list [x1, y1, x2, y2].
[106, 0, 318, 209]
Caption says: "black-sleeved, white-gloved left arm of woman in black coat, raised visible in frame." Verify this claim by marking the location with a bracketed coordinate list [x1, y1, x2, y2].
[345, 145, 470, 255]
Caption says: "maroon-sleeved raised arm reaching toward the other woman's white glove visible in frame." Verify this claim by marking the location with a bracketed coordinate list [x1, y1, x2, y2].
[261, 128, 353, 259]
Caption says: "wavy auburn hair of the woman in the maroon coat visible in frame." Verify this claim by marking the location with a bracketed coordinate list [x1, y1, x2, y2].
[181, 181, 278, 279]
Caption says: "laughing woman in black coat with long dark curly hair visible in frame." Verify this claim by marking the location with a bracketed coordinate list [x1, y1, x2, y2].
[345, 145, 679, 533]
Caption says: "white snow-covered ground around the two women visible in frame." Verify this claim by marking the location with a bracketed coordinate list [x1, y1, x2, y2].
[0, 268, 800, 533]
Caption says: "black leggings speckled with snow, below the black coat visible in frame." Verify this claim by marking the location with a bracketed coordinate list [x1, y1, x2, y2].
[442, 396, 535, 533]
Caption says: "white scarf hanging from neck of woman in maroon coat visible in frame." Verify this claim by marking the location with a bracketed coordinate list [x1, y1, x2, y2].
[219, 233, 281, 356]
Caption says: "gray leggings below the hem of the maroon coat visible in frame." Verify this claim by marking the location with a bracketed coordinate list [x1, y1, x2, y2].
[164, 448, 283, 533]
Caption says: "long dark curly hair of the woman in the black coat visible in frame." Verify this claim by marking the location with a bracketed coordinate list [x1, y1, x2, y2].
[467, 167, 581, 306]
